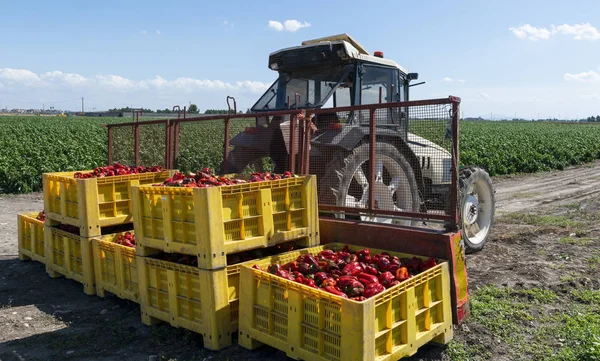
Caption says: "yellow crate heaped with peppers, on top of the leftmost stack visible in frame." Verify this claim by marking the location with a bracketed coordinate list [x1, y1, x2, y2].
[43, 170, 174, 237]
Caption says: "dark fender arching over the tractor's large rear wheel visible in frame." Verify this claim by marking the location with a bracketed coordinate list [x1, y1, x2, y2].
[311, 127, 426, 203]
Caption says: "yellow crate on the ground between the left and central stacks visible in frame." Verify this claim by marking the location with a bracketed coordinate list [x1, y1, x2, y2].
[92, 231, 140, 303]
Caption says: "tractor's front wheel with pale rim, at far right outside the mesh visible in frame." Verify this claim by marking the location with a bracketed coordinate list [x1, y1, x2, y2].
[459, 167, 496, 253]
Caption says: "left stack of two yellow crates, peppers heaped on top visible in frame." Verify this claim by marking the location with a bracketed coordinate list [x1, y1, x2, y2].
[43, 167, 173, 295]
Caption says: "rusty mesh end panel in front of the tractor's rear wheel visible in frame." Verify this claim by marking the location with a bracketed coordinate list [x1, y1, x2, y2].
[310, 103, 453, 224]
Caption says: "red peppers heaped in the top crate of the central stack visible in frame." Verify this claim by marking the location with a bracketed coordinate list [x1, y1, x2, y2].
[154, 168, 294, 188]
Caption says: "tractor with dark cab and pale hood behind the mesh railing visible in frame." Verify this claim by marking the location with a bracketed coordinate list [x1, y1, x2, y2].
[220, 34, 495, 253]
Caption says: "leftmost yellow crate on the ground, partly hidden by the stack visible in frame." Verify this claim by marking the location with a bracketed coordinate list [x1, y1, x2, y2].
[17, 212, 46, 264]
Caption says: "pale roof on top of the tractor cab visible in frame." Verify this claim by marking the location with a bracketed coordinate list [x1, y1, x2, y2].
[269, 33, 408, 74]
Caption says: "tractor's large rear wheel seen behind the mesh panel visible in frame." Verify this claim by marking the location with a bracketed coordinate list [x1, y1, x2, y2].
[319, 142, 421, 225]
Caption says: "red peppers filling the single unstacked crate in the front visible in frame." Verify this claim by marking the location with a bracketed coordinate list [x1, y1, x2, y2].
[252, 246, 437, 301]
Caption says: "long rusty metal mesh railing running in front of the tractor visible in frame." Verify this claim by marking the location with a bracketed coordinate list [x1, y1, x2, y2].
[105, 97, 460, 224]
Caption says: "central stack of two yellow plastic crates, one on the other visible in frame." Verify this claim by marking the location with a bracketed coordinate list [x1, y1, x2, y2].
[132, 175, 319, 350]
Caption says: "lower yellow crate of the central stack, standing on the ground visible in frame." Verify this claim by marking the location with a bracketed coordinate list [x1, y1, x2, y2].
[136, 253, 241, 350]
